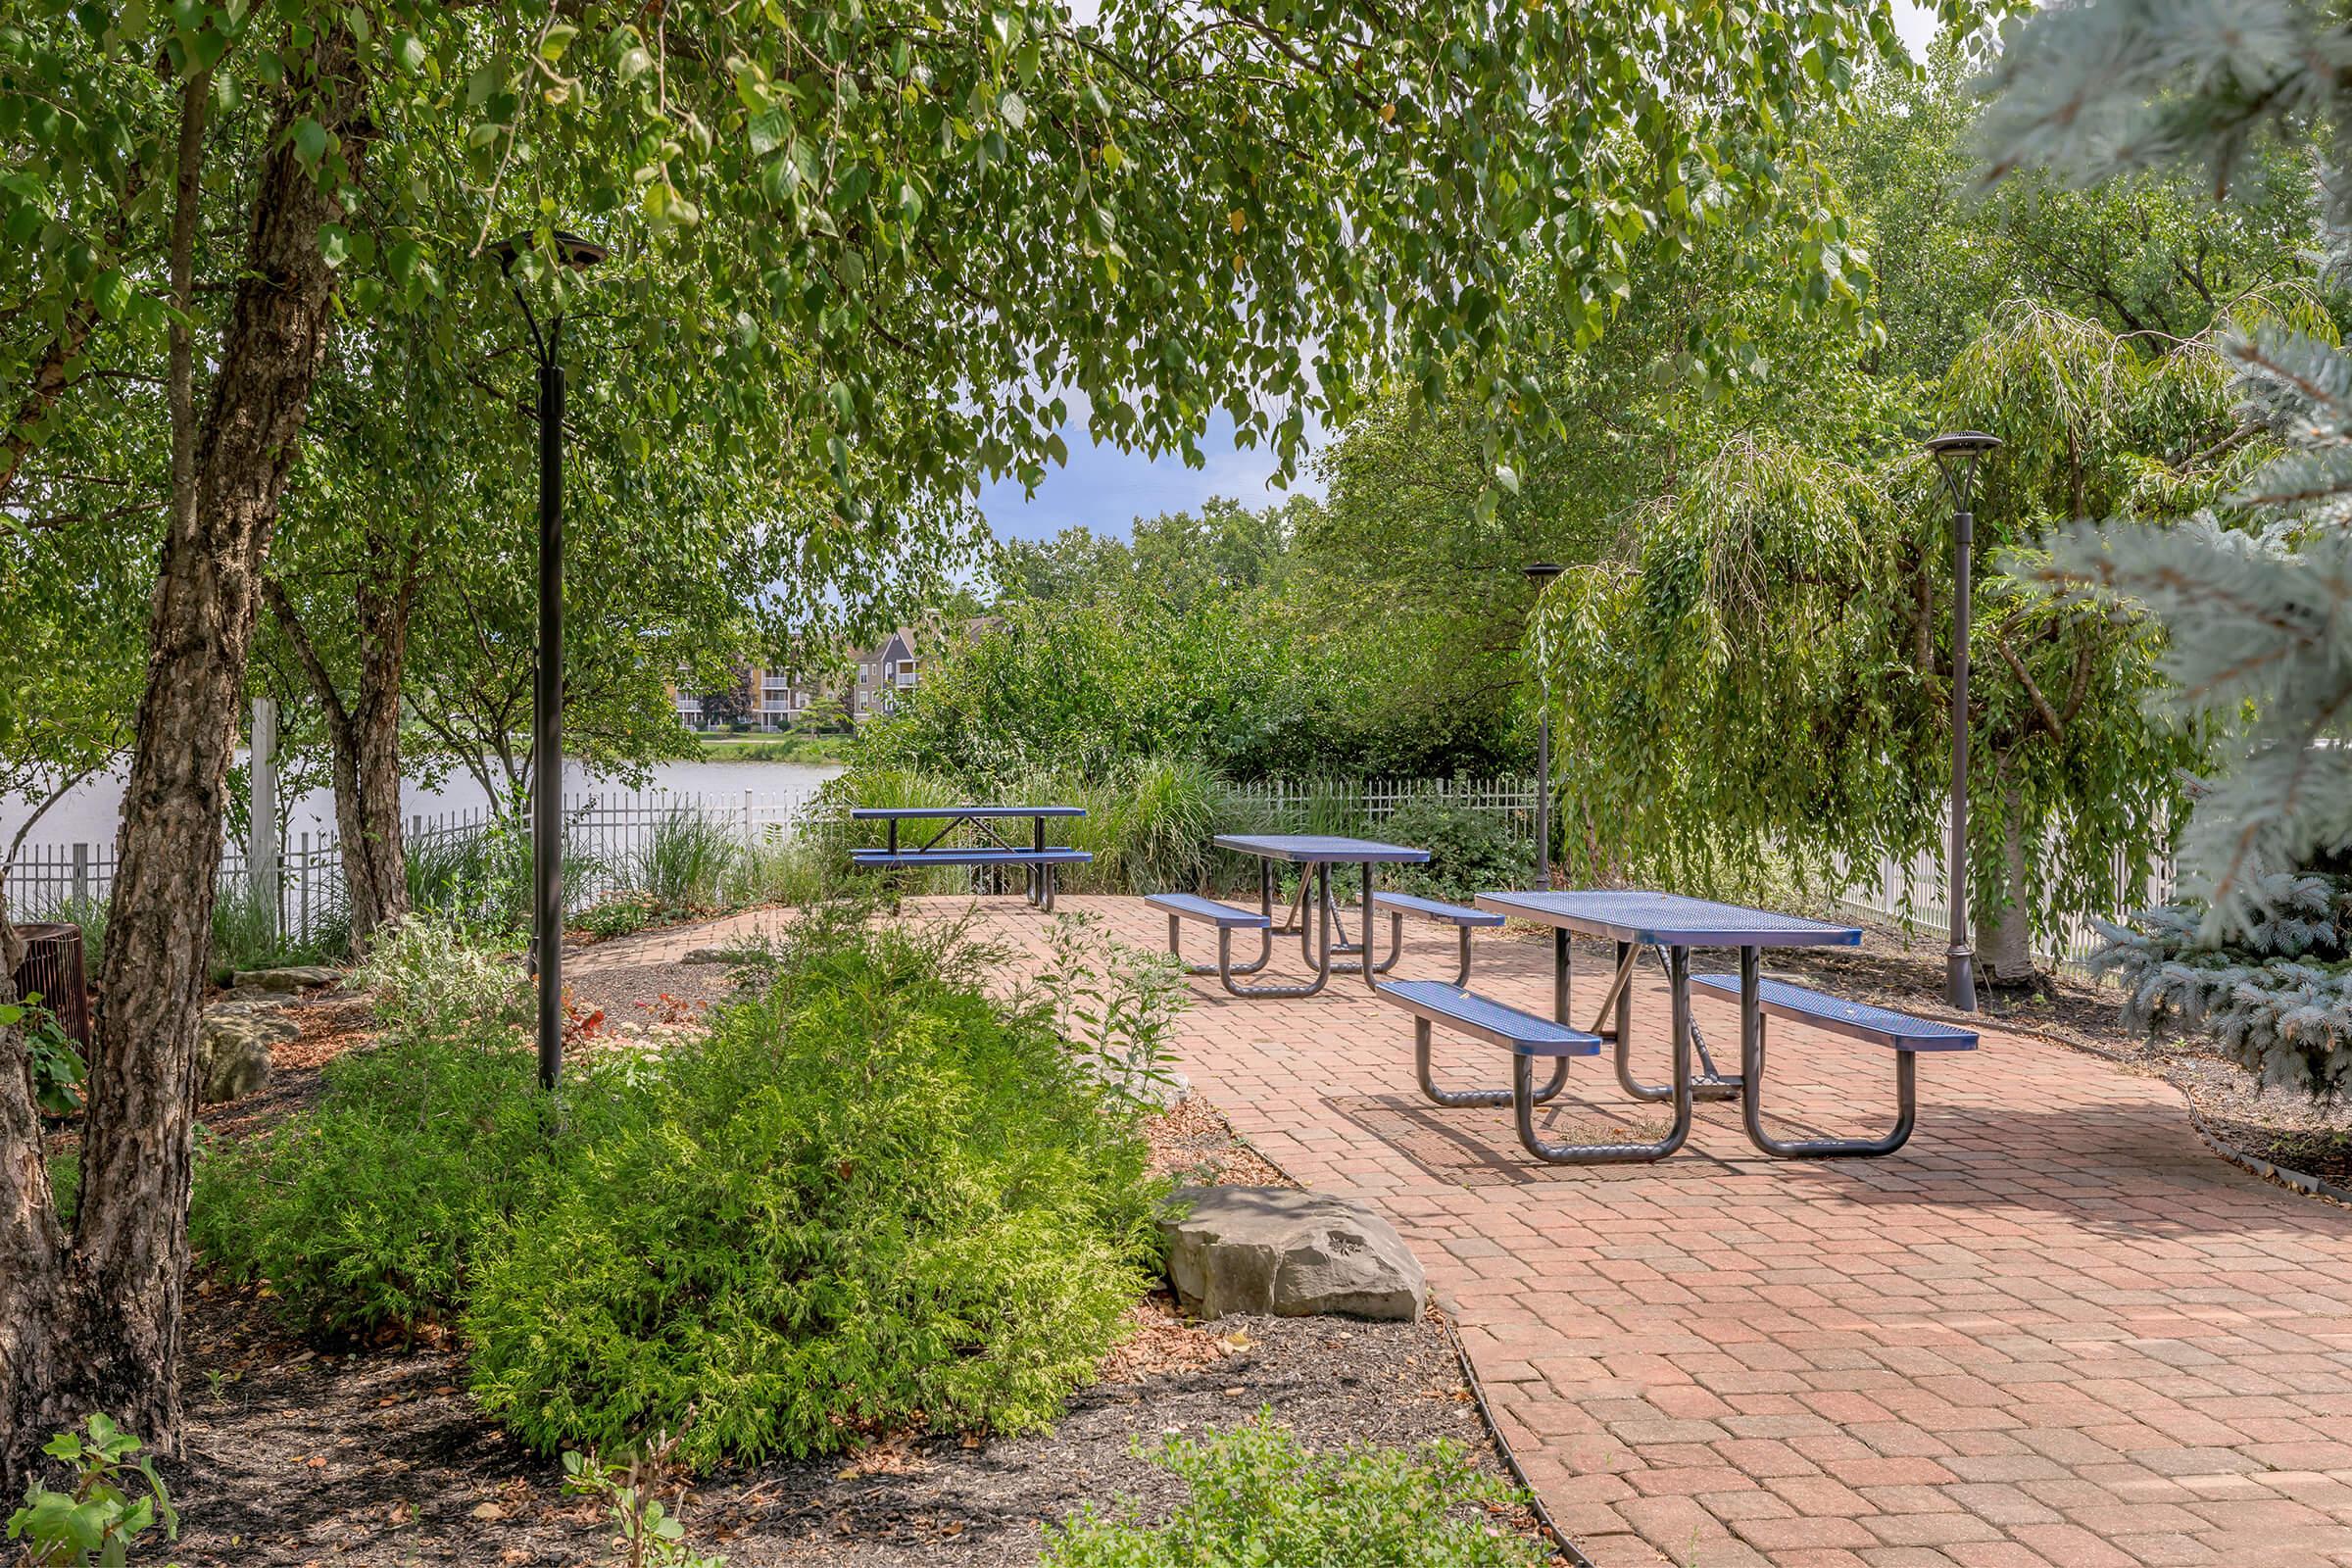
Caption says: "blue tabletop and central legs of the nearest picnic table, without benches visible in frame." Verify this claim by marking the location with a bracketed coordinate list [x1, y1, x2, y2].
[1475, 891, 1872, 1163]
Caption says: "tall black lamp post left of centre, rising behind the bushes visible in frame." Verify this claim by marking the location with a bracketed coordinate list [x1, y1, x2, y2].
[496, 228, 607, 1091]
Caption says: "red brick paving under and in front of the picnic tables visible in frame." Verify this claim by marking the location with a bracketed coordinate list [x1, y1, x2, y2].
[939, 898, 2352, 1568]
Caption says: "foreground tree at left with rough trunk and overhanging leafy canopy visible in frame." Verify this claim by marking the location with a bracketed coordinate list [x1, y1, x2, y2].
[0, 0, 1978, 1474]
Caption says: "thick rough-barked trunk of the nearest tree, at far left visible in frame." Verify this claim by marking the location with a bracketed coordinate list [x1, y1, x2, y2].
[0, 25, 367, 1486]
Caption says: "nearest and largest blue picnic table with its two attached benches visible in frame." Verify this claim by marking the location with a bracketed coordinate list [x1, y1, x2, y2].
[1376, 891, 1976, 1163]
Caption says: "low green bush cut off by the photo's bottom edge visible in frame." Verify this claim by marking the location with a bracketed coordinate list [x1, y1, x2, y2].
[1040, 1410, 1547, 1568]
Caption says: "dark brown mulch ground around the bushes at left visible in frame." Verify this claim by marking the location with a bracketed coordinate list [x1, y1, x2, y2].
[142, 964, 1566, 1568]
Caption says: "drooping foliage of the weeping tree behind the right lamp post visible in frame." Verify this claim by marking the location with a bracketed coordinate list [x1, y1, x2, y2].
[1543, 303, 2228, 980]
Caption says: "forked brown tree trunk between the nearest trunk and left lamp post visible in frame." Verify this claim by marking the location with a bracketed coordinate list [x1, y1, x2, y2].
[264, 570, 416, 953]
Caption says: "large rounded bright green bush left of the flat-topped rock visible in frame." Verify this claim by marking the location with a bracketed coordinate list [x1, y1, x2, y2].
[466, 926, 1151, 1464]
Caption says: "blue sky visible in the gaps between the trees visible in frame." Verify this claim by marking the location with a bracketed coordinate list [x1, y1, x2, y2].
[981, 0, 1936, 550]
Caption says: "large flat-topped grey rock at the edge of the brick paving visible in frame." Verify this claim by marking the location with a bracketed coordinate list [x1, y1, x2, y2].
[1159, 1187, 1428, 1321]
